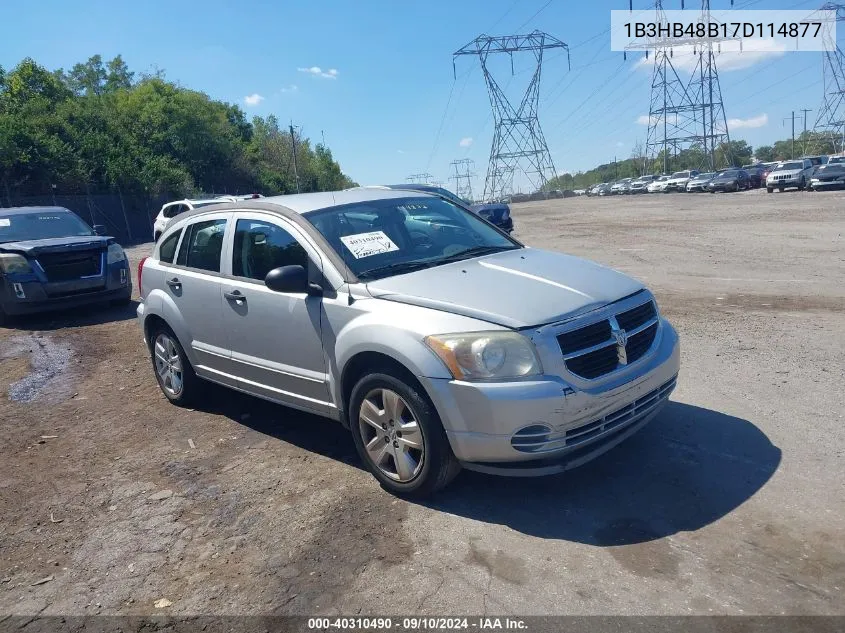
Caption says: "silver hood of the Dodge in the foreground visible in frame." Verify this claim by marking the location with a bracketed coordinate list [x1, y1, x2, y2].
[367, 248, 643, 329]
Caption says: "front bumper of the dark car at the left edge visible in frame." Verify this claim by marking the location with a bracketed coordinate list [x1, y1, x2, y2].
[0, 260, 132, 316]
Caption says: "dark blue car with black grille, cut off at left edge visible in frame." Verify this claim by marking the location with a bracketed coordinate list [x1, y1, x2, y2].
[0, 207, 132, 323]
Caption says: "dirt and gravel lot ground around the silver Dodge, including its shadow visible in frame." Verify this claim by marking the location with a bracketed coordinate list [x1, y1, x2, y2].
[0, 191, 845, 615]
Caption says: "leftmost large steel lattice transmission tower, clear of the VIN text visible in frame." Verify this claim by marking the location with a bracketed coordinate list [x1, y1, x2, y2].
[452, 31, 569, 200]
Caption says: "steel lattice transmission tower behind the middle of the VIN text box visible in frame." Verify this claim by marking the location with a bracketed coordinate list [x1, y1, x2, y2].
[626, 0, 733, 173]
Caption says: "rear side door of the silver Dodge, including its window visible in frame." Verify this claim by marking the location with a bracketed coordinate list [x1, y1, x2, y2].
[163, 213, 237, 387]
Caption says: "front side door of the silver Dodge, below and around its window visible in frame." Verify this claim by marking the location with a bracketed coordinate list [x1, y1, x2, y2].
[223, 211, 334, 414]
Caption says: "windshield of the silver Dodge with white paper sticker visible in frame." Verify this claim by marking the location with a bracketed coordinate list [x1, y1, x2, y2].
[305, 197, 522, 281]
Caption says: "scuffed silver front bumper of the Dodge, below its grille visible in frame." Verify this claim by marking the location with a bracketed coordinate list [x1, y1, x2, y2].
[422, 320, 680, 475]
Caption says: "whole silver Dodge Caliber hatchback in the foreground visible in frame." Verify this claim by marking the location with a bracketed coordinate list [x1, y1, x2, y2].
[138, 189, 680, 495]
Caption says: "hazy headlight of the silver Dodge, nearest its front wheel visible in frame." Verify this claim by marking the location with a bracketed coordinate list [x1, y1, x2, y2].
[425, 332, 541, 380]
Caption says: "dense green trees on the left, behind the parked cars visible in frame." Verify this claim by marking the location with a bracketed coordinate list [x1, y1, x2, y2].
[0, 55, 355, 197]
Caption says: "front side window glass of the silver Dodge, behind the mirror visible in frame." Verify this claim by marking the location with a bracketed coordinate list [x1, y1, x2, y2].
[232, 220, 308, 281]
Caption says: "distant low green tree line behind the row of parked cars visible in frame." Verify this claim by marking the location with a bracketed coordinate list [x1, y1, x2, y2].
[547, 131, 838, 190]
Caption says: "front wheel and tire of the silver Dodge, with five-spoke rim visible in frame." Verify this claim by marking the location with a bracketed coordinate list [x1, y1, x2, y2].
[348, 373, 460, 497]
